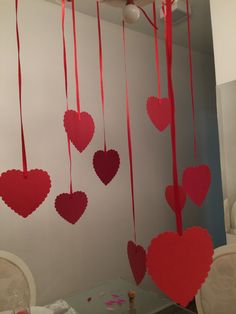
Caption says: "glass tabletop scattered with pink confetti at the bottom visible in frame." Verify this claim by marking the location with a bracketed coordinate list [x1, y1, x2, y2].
[66, 279, 195, 314]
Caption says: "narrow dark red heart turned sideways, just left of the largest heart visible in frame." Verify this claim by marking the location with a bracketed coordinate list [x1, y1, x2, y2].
[127, 241, 146, 285]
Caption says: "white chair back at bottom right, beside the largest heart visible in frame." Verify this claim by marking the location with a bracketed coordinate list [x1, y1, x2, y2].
[196, 244, 236, 314]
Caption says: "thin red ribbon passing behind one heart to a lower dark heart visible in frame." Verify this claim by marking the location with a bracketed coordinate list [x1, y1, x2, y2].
[61, 0, 73, 194]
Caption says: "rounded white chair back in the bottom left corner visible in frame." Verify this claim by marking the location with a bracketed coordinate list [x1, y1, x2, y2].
[0, 251, 36, 311]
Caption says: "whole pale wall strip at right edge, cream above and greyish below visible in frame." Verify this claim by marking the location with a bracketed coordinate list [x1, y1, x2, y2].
[210, 0, 236, 221]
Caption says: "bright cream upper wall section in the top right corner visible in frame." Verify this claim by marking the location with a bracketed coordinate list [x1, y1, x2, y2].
[210, 0, 236, 85]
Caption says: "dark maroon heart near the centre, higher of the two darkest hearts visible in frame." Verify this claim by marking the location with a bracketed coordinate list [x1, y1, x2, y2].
[93, 149, 120, 185]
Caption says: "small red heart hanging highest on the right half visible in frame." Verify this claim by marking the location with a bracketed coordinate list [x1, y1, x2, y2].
[147, 96, 171, 131]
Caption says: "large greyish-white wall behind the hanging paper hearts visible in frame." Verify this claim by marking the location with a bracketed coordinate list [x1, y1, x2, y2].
[0, 0, 220, 303]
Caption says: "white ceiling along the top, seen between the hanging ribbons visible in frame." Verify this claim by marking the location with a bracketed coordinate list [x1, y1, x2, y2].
[47, 0, 213, 54]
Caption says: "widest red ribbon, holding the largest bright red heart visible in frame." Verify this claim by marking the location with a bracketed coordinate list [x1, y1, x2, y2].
[165, 0, 183, 235]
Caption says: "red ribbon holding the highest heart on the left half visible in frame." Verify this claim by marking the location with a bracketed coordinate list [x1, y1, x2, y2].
[71, 0, 80, 118]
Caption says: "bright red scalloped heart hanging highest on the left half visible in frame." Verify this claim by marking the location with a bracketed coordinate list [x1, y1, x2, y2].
[64, 110, 95, 153]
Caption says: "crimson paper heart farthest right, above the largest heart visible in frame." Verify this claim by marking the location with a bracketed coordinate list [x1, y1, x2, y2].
[182, 165, 211, 206]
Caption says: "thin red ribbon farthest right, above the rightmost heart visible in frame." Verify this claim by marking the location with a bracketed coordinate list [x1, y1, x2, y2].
[186, 0, 197, 160]
